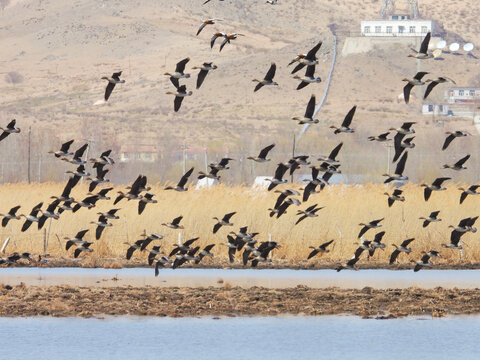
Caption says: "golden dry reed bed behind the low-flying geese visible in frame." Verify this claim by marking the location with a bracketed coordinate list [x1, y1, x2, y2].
[0, 183, 480, 265]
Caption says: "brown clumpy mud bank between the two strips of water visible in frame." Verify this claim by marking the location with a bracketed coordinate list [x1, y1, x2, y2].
[0, 283, 480, 318]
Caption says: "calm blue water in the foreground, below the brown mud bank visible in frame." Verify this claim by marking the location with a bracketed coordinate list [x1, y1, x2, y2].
[0, 316, 480, 360]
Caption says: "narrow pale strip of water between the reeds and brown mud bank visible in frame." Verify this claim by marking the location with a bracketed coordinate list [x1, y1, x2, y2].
[0, 268, 480, 289]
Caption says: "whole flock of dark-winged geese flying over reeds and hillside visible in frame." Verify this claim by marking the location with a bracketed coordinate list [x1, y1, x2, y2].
[0, 4, 480, 276]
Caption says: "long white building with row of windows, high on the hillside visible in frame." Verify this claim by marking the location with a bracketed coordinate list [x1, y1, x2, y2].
[360, 15, 435, 36]
